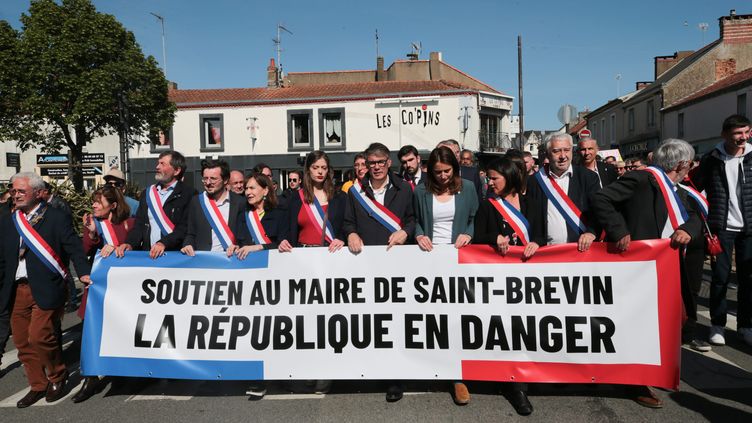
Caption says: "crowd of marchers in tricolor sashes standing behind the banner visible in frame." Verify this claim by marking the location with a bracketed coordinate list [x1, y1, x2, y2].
[0, 115, 752, 415]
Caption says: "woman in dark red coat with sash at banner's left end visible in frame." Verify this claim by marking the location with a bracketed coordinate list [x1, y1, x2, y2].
[78, 185, 135, 403]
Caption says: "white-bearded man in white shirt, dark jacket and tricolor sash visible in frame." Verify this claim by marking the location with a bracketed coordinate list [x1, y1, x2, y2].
[526, 134, 600, 251]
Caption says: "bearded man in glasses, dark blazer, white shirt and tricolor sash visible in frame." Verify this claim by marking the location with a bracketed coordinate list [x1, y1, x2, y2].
[180, 160, 251, 257]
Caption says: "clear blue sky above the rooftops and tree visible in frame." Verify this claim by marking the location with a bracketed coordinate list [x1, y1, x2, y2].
[0, 0, 752, 129]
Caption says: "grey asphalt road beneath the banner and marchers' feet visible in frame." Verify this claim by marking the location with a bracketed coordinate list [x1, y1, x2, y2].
[0, 275, 752, 423]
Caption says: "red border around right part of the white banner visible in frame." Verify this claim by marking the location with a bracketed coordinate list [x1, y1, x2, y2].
[458, 239, 682, 389]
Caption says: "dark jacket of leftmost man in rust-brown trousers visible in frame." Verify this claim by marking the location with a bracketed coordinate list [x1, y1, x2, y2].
[0, 207, 91, 310]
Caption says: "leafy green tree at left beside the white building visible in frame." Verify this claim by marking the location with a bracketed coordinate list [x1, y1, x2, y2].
[0, 0, 175, 189]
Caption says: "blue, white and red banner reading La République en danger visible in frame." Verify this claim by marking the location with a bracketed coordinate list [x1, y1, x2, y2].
[81, 240, 681, 388]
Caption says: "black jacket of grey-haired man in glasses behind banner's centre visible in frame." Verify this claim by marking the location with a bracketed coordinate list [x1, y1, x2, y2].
[343, 172, 415, 245]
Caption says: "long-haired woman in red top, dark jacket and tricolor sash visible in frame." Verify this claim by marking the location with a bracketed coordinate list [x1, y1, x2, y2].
[279, 150, 347, 252]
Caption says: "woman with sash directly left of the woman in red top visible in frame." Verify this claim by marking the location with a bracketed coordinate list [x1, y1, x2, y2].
[237, 173, 284, 260]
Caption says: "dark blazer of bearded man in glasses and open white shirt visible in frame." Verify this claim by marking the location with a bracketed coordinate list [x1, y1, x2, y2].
[183, 193, 253, 251]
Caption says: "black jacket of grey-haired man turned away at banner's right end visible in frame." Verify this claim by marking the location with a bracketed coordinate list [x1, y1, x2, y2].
[591, 171, 702, 242]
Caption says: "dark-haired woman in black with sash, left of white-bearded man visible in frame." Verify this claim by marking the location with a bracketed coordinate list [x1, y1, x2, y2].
[473, 157, 539, 415]
